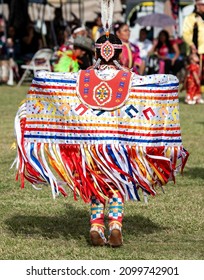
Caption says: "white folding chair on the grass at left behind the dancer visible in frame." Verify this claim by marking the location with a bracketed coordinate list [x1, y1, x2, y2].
[17, 48, 53, 87]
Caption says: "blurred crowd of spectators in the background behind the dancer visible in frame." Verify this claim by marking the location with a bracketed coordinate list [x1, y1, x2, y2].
[0, 0, 204, 104]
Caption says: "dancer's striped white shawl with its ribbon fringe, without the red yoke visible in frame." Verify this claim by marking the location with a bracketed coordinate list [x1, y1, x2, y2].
[15, 72, 188, 203]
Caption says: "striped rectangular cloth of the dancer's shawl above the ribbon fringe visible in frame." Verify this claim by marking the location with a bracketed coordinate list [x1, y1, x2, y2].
[24, 70, 182, 147]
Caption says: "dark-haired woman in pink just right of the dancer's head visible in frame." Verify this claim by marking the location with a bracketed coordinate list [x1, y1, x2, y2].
[114, 22, 143, 74]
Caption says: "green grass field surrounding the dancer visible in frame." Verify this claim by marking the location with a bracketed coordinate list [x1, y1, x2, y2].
[0, 86, 204, 260]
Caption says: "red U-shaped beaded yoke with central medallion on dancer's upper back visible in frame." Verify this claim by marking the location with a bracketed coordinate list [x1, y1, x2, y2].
[76, 69, 132, 111]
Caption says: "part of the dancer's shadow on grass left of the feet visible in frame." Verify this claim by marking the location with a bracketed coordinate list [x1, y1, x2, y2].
[5, 206, 89, 242]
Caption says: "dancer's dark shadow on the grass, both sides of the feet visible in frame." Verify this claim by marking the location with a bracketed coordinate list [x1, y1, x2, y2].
[5, 206, 164, 244]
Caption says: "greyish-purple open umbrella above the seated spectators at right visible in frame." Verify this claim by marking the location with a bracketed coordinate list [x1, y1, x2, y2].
[135, 13, 176, 27]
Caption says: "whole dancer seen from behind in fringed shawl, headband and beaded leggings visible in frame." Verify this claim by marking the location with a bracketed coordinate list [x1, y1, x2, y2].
[15, 1, 188, 246]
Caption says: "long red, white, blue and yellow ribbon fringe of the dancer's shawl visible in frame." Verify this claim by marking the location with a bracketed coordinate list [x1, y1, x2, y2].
[15, 101, 188, 202]
